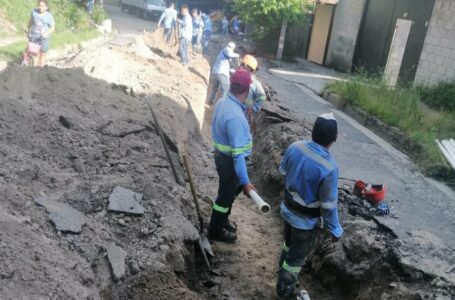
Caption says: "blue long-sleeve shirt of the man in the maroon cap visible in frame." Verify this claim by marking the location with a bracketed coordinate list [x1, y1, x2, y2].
[212, 94, 253, 185]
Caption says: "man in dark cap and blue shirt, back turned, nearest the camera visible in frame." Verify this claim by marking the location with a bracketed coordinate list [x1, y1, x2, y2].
[276, 113, 343, 299]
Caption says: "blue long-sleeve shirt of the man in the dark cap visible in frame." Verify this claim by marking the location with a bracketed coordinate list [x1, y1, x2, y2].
[280, 141, 343, 237]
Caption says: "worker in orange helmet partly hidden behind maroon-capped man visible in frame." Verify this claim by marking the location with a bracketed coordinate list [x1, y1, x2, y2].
[240, 55, 267, 114]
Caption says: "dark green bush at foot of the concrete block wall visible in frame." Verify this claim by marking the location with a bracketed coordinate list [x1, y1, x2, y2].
[418, 82, 455, 112]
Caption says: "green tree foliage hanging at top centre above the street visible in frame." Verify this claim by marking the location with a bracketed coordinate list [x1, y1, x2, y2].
[234, 0, 313, 39]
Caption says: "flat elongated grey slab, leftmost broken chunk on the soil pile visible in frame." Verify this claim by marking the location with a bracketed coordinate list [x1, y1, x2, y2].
[34, 195, 87, 233]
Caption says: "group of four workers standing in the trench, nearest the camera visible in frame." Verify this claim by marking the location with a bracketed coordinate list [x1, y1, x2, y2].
[208, 42, 343, 299]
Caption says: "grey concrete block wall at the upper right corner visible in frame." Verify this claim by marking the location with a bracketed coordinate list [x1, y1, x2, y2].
[415, 0, 455, 85]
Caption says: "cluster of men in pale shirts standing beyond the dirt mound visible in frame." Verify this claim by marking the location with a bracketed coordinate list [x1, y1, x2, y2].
[158, 2, 212, 65]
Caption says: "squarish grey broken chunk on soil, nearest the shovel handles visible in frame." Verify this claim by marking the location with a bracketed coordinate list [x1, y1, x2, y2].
[108, 186, 144, 215]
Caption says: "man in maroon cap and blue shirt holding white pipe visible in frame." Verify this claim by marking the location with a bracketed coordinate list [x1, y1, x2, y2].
[209, 70, 255, 243]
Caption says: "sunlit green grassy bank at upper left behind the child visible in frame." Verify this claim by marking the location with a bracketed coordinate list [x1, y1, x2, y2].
[0, 0, 106, 59]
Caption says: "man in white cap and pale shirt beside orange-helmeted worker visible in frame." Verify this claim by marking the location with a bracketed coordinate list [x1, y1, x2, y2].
[209, 42, 239, 104]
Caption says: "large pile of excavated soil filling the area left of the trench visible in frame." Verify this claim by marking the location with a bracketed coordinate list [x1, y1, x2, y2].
[0, 31, 214, 299]
